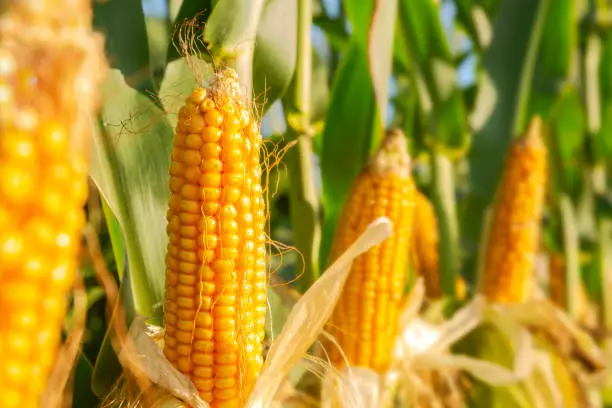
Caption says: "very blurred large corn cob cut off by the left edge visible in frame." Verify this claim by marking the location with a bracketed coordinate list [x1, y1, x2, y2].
[0, 0, 103, 408]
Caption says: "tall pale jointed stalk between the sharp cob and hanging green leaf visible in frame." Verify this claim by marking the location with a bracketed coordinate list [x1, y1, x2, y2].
[285, 0, 321, 291]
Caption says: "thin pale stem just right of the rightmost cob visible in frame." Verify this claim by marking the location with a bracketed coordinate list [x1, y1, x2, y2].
[559, 194, 581, 319]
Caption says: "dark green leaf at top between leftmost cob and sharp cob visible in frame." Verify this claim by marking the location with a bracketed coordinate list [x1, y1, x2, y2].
[93, 0, 155, 94]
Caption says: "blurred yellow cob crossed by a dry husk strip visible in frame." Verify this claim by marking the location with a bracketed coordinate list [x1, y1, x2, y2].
[327, 132, 415, 371]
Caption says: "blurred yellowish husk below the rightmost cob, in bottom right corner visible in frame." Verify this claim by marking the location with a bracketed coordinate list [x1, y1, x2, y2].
[462, 299, 604, 408]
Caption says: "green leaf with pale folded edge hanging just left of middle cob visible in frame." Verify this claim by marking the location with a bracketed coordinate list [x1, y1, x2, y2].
[319, 0, 397, 270]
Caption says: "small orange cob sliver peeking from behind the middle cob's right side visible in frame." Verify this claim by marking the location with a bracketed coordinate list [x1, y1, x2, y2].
[412, 191, 442, 299]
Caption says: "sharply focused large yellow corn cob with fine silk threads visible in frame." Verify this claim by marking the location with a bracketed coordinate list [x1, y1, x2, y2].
[164, 69, 267, 407]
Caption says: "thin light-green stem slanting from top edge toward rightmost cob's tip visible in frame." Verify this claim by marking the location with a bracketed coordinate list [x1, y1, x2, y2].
[512, 0, 551, 137]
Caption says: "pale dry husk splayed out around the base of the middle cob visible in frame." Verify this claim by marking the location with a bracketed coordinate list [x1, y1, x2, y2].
[322, 280, 535, 408]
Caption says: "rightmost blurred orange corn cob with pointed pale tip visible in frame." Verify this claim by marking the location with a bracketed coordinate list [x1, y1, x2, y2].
[480, 117, 547, 303]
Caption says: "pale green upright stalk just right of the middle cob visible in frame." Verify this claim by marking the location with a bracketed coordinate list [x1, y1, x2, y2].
[431, 151, 459, 297]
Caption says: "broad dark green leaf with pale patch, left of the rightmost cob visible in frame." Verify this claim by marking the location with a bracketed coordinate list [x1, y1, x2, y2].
[460, 0, 550, 281]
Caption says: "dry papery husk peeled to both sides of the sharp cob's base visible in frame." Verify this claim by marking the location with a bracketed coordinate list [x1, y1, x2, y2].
[103, 217, 392, 408]
